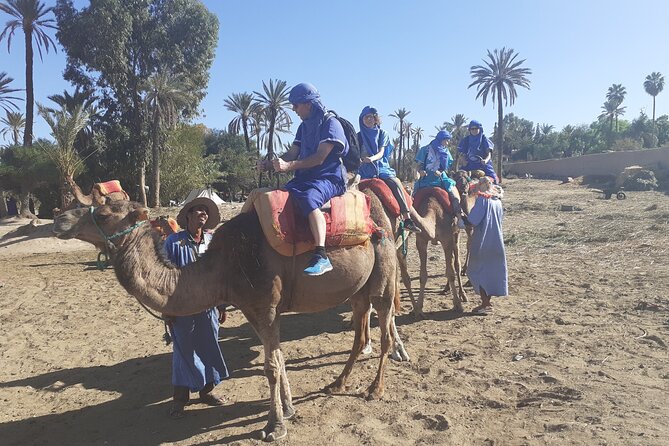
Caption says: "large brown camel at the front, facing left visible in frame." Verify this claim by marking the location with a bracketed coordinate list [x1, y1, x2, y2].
[54, 195, 397, 441]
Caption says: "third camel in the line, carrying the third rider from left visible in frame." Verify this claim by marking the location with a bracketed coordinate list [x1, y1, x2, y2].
[399, 188, 467, 318]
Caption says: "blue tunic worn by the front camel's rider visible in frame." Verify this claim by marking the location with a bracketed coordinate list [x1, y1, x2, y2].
[285, 117, 348, 216]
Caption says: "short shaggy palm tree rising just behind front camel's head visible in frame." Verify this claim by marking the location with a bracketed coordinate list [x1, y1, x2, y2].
[37, 104, 91, 206]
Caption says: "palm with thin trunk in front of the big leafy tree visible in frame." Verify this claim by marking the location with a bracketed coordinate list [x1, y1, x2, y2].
[142, 70, 191, 207]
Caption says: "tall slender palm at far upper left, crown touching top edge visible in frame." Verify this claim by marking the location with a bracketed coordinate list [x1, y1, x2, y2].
[0, 0, 57, 146]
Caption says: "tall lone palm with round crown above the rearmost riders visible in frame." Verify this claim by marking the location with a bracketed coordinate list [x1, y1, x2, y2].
[467, 47, 532, 181]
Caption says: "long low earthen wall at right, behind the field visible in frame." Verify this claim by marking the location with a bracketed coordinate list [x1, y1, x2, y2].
[504, 147, 669, 177]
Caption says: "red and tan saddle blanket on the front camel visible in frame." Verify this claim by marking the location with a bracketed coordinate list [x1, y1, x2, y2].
[242, 189, 376, 257]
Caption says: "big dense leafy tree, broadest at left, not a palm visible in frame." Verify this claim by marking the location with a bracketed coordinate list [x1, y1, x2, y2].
[56, 0, 218, 203]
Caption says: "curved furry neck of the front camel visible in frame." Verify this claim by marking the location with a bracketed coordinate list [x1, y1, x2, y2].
[109, 226, 225, 316]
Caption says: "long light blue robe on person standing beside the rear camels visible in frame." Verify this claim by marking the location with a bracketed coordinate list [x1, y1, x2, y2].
[467, 197, 509, 296]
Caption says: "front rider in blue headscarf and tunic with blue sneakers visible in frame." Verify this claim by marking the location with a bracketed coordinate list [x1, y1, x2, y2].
[272, 83, 348, 276]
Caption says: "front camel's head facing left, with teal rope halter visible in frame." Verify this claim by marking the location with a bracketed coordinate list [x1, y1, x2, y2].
[53, 201, 149, 250]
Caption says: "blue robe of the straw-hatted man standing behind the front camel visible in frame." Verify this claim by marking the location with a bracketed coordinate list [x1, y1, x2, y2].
[165, 231, 229, 392]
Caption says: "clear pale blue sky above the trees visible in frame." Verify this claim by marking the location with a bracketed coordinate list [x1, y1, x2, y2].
[0, 0, 669, 144]
